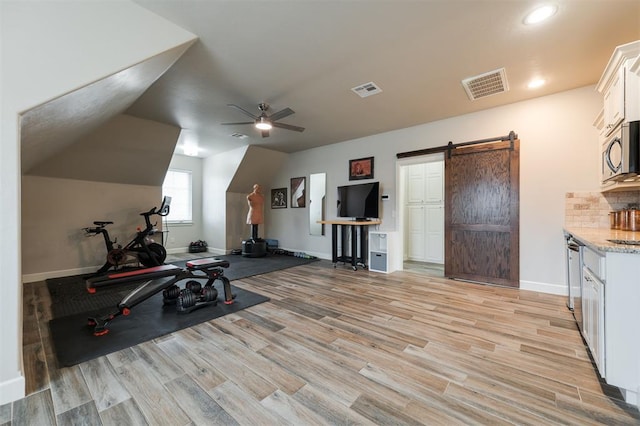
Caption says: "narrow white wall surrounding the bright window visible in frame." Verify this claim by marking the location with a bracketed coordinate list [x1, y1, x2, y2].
[163, 154, 204, 253]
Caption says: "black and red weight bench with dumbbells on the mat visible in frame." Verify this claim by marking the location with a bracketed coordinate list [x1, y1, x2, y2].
[87, 258, 235, 336]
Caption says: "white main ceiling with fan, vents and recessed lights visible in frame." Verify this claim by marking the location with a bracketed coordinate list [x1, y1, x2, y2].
[127, 0, 640, 157]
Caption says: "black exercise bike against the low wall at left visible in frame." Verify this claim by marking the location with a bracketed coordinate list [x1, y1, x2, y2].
[82, 197, 171, 275]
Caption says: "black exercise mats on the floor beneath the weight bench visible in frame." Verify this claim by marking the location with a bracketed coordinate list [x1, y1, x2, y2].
[46, 254, 314, 366]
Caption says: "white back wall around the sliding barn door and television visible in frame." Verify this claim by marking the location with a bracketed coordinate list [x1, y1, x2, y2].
[266, 86, 602, 294]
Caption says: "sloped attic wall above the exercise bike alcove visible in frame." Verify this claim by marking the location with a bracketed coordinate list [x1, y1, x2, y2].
[21, 42, 191, 184]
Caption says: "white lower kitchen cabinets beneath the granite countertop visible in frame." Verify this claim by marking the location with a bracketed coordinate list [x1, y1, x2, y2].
[567, 229, 640, 405]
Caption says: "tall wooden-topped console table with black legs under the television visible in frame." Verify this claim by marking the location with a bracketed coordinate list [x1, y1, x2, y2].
[318, 219, 382, 271]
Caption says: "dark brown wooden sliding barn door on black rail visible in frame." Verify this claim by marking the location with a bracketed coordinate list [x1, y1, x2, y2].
[445, 139, 520, 287]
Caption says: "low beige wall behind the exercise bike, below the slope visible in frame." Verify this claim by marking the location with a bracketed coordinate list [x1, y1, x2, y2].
[22, 176, 162, 282]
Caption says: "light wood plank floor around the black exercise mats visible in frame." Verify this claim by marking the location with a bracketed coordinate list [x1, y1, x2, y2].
[5, 261, 640, 426]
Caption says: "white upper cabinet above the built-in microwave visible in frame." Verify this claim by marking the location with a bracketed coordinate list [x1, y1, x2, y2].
[596, 40, 640, 136]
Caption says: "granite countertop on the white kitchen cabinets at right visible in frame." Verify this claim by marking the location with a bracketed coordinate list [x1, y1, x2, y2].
[564, 227, 640, 254]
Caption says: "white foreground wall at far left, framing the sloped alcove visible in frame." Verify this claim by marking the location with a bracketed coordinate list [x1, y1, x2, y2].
[0, 0, 193, 404]
